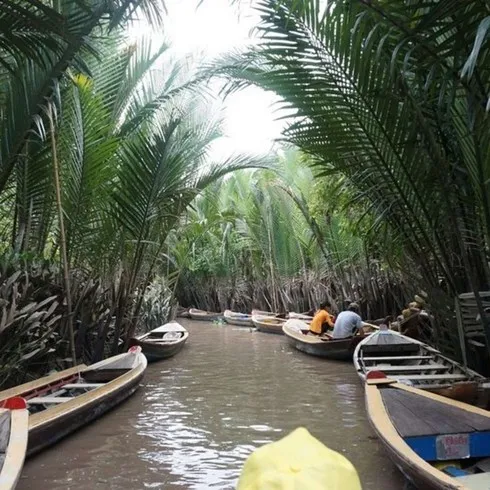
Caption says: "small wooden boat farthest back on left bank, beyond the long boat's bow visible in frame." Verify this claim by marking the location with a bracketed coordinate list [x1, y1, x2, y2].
[129, 322, 189, 362]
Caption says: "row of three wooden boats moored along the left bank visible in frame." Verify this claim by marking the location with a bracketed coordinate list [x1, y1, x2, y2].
[0, 322, 189, 490]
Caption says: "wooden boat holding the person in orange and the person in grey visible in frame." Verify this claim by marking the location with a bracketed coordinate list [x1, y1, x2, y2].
[282, 319, 365, 361]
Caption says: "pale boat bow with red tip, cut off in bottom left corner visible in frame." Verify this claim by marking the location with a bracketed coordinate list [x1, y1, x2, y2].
[0, 397, 29, 490]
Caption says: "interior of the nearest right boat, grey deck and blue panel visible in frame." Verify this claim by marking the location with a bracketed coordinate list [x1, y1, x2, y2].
[380, 386, 490, 490]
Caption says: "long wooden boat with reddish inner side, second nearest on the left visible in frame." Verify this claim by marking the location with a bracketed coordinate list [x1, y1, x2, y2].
[0, 346, 147, 456]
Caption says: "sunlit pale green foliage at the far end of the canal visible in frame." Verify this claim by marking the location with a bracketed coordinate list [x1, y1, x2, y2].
[170, 149, 413, 317]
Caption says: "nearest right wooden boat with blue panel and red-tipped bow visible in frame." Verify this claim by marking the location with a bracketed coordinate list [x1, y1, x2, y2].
[366, 371, 490, 490]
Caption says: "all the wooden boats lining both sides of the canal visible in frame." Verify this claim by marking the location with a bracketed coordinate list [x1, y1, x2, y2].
[0, 302, 490, 490]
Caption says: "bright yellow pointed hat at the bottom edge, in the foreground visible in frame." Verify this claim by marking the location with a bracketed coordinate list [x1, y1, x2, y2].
[237, 427, 361, 490]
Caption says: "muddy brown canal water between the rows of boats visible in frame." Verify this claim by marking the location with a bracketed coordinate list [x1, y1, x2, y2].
[17, 320, 404, 490]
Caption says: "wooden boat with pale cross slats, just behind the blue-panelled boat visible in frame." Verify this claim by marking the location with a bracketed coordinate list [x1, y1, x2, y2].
[353, 330, 485, 403]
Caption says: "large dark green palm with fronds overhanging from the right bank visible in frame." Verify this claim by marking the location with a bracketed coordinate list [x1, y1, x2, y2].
[214, 0, 490, 352]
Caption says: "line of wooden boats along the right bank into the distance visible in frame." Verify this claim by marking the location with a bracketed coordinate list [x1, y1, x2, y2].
[183, 304, 490, 490]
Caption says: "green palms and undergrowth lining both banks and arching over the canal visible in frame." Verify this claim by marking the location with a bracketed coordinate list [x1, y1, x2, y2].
[0, 0, 490, 385]
